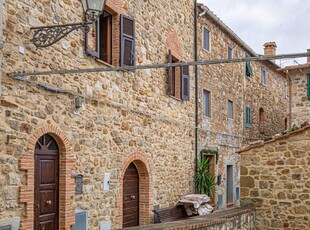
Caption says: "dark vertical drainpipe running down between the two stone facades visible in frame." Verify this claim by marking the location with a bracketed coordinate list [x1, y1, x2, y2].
[194, 0, 199, 192]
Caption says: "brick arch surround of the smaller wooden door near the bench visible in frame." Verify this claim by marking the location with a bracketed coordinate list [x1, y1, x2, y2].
[117, 152, 153, 226]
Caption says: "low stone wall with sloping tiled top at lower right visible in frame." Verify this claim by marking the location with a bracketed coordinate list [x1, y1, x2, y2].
[240, 126, 310, 230]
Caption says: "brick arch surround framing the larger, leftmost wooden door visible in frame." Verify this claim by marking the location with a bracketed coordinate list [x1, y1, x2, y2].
[19, 125, 76, 230]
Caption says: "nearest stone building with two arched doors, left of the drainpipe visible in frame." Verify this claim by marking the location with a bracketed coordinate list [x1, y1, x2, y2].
[0, 0, 195, 230]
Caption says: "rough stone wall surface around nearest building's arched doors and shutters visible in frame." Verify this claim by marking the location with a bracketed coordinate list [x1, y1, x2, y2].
[0, 0, 194, 229]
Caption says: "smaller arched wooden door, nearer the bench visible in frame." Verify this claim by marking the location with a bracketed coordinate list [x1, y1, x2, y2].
[123, 163, 139, 228]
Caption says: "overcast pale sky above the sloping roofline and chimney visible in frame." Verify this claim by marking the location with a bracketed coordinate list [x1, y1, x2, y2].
[198, 0, 310, 65]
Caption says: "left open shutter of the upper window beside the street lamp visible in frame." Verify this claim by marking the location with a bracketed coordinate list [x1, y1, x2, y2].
[85, 19, 100, 58]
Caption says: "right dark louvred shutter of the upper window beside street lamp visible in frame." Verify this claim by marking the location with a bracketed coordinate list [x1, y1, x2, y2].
[120, 15, 136, 66]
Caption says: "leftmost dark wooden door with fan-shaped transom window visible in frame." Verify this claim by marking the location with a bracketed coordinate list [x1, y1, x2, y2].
[34, 134, 59, 230]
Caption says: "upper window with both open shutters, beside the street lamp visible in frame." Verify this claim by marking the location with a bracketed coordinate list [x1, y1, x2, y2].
[85, 11, 135, 66]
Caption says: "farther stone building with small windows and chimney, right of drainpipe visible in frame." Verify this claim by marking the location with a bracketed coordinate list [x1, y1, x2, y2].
[198, 5, 288, 208]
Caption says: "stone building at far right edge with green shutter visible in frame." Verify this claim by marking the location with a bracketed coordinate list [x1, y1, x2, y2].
[279, 50, 310, 127]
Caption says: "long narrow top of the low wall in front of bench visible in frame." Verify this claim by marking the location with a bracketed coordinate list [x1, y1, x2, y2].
[125, 207, 255, 230]
